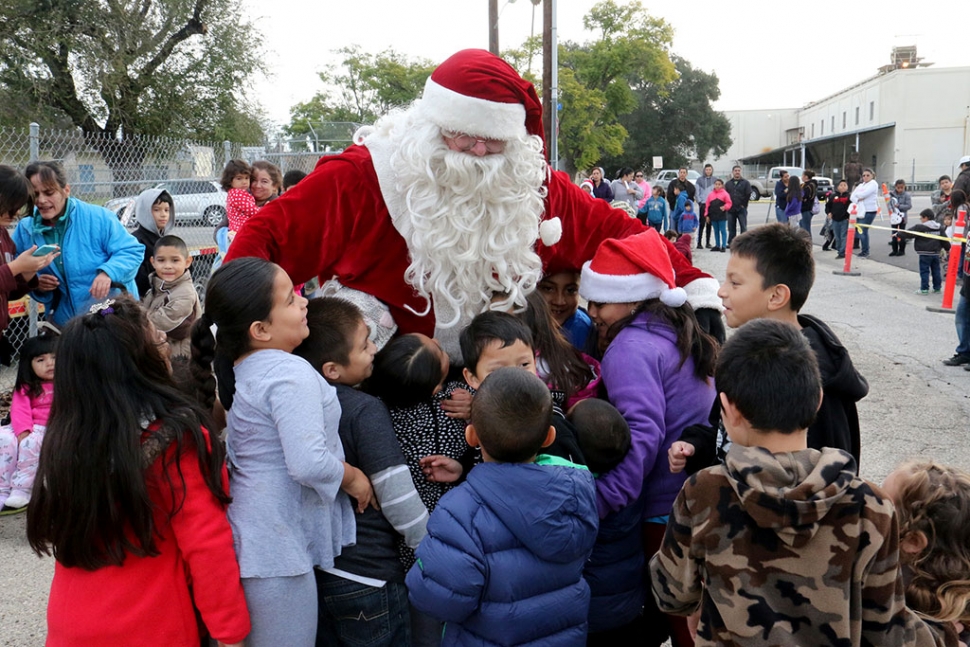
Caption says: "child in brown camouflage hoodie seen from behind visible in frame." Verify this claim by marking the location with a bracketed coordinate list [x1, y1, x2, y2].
[650, 319, 936, 646]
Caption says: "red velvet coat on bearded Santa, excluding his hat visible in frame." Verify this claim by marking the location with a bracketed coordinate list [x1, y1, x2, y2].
[226, 146, 720, 336]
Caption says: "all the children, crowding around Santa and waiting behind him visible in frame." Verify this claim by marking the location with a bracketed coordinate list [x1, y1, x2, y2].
[0, 156, 970, 647]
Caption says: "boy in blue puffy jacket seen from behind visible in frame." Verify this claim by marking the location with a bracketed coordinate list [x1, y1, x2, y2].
[407, 367, 597, 647]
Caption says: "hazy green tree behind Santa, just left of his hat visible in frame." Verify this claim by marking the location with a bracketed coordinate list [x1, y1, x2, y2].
[283, 45, 435, 151]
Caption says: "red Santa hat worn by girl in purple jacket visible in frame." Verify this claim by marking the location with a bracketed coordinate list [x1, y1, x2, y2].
[579, 229, 687, 308]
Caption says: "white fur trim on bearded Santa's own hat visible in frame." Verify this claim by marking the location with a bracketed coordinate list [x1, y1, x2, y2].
[421, 76, 527, 140]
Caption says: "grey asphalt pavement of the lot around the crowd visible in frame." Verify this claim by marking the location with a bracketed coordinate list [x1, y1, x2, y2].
[0, 210, 970, 647]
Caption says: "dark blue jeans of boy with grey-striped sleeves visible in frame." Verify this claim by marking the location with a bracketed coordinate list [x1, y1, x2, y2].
[313, 569, 411, 647]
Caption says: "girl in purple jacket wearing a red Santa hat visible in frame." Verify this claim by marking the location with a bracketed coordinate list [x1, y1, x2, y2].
[579, 230, 717, 647]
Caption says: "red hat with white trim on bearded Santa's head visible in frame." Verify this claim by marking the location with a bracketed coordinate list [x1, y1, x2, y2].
[421, 49, 543, 148]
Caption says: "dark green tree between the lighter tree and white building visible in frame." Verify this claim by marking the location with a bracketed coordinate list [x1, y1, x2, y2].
[604, 56, 731, 173]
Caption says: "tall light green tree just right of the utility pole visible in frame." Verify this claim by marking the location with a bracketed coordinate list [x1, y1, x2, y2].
[559, 0, 676, 168]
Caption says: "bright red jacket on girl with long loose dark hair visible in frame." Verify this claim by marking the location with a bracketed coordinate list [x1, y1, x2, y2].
[47, 430, 250, 647]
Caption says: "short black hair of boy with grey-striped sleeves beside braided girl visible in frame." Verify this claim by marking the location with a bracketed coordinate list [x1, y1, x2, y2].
[293, 297, 364, 371]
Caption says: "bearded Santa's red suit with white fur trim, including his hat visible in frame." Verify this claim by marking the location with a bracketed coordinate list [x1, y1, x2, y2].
[226, 50, 721, 336]
